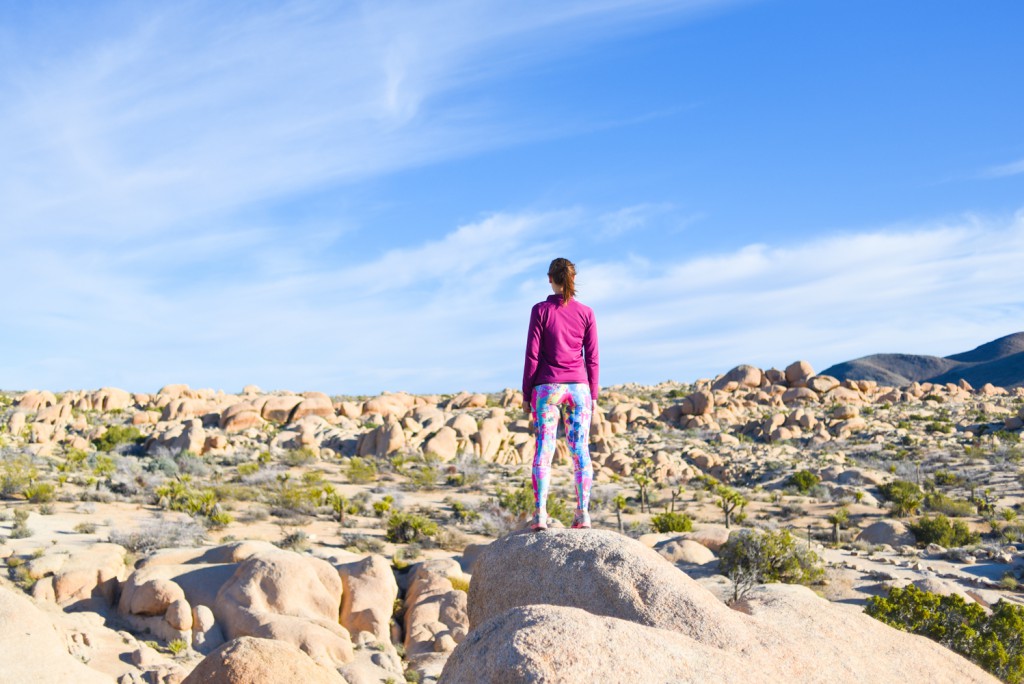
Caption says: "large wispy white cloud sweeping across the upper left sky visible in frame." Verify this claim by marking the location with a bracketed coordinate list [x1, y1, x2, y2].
[0, 0, 729, 245]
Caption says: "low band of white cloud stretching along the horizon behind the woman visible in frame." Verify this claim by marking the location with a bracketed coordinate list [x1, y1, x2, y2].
[0, 209, 1024, 392]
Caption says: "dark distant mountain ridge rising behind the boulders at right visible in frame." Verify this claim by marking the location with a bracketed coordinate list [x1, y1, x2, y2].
[822, 333, 1024, 388]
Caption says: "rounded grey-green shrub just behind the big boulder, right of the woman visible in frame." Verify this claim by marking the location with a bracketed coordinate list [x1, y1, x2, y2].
[719, 529, 824, 600]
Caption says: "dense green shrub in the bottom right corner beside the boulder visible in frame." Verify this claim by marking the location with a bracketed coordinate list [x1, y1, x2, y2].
[864, 585, 1024, 684]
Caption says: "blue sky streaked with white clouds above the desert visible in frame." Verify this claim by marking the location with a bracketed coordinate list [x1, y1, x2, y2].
[0, 0, 1024, 394]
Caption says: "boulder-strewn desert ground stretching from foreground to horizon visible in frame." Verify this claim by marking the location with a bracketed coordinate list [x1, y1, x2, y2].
[0, 361, 1024, 684]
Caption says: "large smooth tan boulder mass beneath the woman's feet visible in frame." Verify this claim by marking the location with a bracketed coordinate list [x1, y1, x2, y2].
[441, 529, 997, 684]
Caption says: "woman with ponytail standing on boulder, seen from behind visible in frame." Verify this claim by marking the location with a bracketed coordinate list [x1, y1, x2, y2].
[522, 259, 598, 529]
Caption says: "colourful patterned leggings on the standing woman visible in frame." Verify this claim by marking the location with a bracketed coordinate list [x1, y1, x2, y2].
[532, 383, 594, 512]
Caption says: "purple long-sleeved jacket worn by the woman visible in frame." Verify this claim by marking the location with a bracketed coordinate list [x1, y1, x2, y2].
[522, 295, 598, 401]
